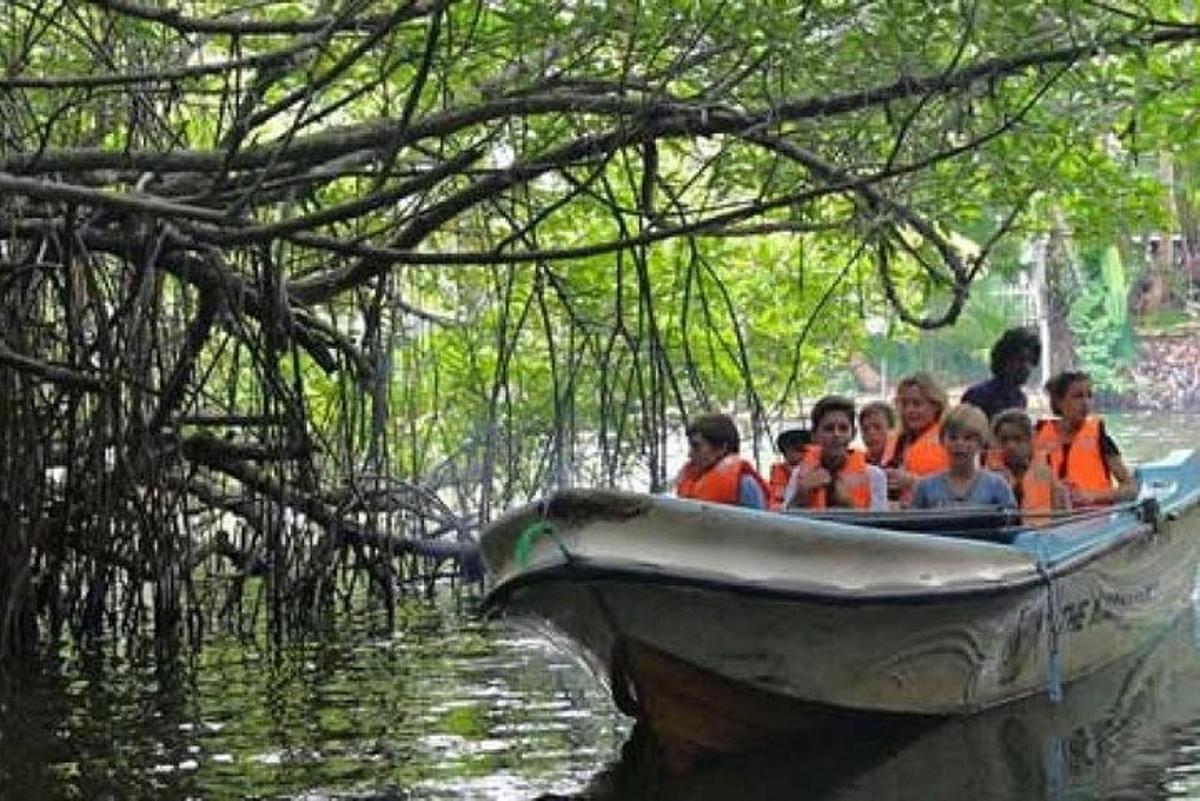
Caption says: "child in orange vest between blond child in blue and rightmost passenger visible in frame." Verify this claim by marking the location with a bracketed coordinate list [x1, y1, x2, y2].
[988, 409, 1070, 525]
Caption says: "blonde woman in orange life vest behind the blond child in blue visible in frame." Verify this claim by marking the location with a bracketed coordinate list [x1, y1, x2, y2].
[883, 373, 950, 506]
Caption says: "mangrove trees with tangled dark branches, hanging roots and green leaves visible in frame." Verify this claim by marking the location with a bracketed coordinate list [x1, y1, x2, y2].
[0, 0, 1200, 658]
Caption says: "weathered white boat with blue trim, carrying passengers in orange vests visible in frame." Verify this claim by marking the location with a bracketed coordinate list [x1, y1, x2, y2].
[480, 451, 1200, 767]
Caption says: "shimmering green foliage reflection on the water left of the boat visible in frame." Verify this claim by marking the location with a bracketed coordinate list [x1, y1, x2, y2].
[0, 604, 628, 800]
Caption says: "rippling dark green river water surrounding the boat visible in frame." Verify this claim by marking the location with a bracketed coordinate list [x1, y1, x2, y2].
[0, 414, 1200, 801]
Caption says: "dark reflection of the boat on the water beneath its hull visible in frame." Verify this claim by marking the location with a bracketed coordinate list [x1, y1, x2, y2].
[566, 612, 1200, 801]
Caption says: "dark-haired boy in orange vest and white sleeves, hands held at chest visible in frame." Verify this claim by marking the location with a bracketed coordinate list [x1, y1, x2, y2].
[785, 395, 887, 510]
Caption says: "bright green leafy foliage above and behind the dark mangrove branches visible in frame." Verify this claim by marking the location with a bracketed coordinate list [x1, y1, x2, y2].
[0, 0, 1200, 508]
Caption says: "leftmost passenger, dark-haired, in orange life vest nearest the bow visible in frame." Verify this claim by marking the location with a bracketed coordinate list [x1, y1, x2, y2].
[676, 414, 767, 508]
